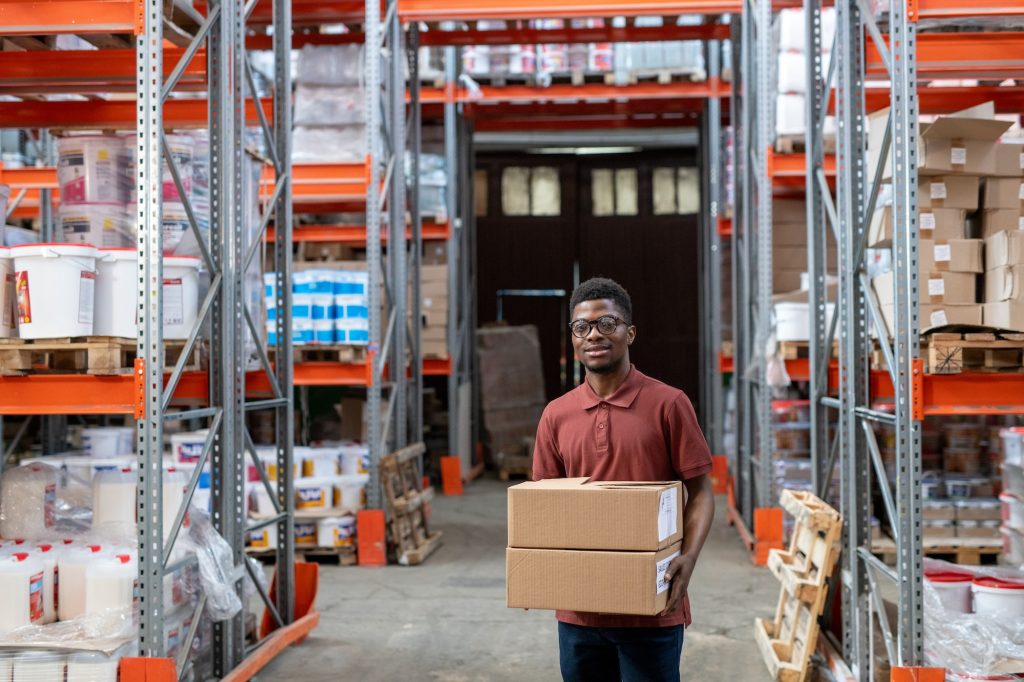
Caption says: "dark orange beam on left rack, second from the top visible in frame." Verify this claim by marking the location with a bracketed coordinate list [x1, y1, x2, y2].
[0, 47, 206, 94]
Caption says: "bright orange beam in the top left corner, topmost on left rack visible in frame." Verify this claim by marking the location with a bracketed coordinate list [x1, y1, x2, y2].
[0, 0, 138, 36]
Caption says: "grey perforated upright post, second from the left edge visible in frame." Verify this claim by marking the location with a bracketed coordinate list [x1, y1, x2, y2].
[207, 0, 246, 677]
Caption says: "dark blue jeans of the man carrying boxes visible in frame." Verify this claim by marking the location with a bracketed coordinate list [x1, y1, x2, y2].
[558, 623, 683, 682]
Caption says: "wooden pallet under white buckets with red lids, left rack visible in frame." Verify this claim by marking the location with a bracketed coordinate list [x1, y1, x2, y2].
[0, 336, 202, 377]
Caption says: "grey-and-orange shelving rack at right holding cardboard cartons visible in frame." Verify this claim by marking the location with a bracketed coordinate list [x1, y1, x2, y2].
[805, 0, 1024, 679]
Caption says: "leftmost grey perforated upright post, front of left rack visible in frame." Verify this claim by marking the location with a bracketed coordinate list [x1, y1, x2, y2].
[135, 0, 165, 656]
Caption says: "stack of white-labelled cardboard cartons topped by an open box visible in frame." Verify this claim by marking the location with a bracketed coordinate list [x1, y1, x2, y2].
[868, 102, 1024, 334]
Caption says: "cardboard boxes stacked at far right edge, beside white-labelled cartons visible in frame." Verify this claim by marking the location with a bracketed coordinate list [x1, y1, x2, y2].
[981, 168, 1024, 331]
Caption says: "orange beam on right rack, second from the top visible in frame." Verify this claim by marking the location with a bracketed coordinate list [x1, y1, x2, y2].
[864, 32, 1024, 80]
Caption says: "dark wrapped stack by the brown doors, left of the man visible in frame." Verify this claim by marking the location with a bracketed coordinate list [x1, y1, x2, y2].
[476, 325, 547, 468]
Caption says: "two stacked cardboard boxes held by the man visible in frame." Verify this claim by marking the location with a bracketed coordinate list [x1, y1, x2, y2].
[506, 478, 684, 615]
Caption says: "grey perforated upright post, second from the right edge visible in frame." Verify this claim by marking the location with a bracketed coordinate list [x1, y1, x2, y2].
[836, 1, 870, 667]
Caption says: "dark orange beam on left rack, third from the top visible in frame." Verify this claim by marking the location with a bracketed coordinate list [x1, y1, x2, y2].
[0, 98, 273, 130]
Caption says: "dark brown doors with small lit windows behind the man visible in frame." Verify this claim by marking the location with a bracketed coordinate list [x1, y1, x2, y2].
[476, 150, 699, 407]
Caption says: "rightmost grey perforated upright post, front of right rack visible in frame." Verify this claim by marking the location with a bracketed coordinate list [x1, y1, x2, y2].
[889, 2, 924, 666]
